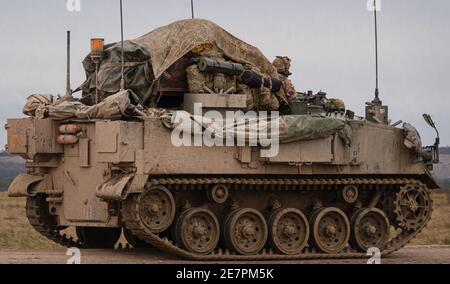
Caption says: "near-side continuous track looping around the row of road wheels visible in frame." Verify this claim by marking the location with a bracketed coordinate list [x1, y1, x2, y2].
[122, 178, 429, 261]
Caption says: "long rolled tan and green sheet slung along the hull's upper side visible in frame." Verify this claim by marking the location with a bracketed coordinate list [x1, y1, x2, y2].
[161, 111, 353, 145]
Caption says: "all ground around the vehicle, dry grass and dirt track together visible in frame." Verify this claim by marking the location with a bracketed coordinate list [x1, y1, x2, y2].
[0, 193, 450, 264]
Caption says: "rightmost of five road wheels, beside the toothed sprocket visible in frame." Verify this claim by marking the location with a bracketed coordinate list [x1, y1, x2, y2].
[350, 208, 390, 252]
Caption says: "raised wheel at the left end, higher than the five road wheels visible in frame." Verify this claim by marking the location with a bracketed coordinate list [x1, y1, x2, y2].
[138, 186, 175, 234]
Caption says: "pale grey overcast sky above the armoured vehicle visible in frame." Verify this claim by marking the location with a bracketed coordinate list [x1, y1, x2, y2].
[0, 0, 450, 148]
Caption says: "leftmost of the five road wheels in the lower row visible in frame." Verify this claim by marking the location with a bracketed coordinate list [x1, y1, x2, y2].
[175, 208, 220, 255]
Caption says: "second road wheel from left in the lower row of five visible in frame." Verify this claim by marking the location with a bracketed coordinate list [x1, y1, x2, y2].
[224, 208, 268, 255]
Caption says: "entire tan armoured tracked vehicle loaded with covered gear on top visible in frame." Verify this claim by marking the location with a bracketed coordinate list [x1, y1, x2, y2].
[6, 20, 439, 260]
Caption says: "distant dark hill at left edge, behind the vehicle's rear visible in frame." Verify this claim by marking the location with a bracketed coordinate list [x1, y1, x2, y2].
[0, 151, 26, 191]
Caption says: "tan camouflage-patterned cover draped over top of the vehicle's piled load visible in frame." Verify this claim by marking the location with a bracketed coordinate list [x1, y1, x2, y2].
[131, 19, 277, 78]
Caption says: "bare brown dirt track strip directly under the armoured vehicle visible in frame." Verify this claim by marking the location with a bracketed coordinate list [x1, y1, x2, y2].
[0, 246, 450, 264]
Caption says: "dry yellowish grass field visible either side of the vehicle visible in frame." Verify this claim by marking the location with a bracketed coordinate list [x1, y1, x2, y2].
[0, 193, 450, 249]
